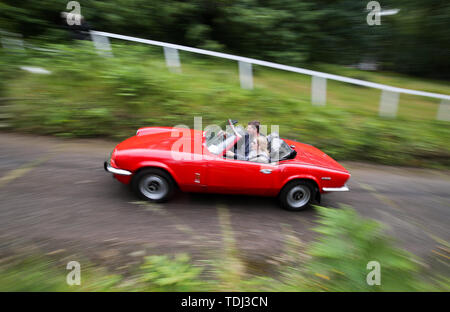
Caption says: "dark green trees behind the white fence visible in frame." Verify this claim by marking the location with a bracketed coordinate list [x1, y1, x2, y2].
[0, 0, 450, 78]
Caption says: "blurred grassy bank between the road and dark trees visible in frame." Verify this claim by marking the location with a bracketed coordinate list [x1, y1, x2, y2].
[0, 42, 450, 168]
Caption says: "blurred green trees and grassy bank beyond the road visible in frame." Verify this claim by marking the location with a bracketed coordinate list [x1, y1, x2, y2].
[0, 0, 450, 166]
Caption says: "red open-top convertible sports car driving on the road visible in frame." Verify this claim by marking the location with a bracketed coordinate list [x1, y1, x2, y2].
[104, 120, 350, 211]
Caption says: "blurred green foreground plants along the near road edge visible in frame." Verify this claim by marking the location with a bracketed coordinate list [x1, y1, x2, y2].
[0, 207, 450, 291]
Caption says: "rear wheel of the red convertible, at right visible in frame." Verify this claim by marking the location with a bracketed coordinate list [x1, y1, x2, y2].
[279, 180, 316, 211]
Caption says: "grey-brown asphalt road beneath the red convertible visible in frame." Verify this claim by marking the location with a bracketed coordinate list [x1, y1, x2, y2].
[0, 133, 450, 269]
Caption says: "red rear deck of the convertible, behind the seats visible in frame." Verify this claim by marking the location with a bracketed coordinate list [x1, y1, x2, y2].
[285, 140, 348, 173]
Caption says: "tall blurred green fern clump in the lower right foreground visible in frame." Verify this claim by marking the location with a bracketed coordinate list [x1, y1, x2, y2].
[307, 207, 421, 291]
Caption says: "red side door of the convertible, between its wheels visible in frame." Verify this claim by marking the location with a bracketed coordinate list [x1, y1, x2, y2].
[206, 157, 279, 195]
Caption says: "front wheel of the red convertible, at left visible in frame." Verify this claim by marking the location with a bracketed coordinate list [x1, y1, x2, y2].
[131, 168, 176, 203]
